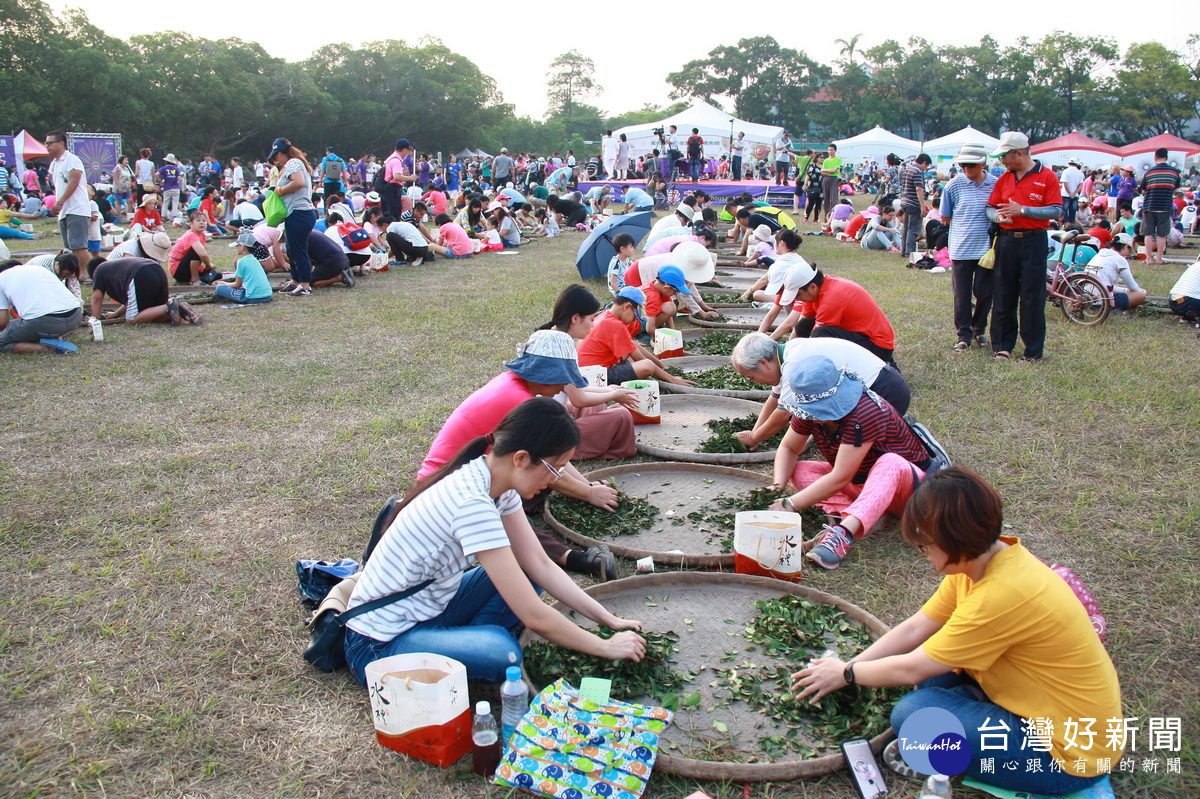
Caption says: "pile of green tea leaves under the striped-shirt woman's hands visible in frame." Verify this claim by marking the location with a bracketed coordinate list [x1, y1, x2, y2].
[524, 626, 695, 709]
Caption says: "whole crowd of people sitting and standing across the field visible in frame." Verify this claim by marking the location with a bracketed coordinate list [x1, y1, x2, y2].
[0, 124, 1200, 793]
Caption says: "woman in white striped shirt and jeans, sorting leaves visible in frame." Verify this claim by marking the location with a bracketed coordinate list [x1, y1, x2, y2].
[346, 397, 646, 684]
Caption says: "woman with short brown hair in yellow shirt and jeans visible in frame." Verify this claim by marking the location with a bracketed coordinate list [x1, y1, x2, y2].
[792, 467, 1123, 795]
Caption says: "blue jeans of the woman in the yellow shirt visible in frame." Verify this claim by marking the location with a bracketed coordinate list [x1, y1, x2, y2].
[892, 672, 1116, 794]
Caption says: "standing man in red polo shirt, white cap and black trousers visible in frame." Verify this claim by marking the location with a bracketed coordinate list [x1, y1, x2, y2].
[988, 131, 1062, 364]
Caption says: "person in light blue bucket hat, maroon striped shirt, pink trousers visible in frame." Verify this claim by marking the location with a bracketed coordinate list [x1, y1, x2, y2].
[770, 355, 930, 569]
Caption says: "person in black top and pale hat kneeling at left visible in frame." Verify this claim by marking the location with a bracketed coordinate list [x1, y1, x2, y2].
[88, 258, 202, 325]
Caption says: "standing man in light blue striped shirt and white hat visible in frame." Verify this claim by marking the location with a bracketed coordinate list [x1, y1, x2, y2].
[941, 144, 996, 353]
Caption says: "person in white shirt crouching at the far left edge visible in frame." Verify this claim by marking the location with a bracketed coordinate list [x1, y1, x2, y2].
[0, 260, 83, 354]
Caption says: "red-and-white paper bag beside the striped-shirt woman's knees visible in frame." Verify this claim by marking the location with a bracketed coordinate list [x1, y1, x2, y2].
[366, 653, 473, 768]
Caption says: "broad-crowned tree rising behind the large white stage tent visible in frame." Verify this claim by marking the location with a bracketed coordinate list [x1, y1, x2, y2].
[667, 36, 830, 136]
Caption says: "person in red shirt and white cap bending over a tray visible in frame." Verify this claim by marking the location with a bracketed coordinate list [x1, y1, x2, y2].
[772, 264, 896, 366]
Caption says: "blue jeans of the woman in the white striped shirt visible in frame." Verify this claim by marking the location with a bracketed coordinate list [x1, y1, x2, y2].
[346, 566, 541, 685]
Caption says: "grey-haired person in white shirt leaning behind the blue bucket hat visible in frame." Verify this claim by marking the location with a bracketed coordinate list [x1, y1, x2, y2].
[730, 332, 912, 451]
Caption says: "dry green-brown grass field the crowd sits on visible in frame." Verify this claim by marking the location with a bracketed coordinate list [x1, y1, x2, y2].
[0, 208, 1200, 798]
